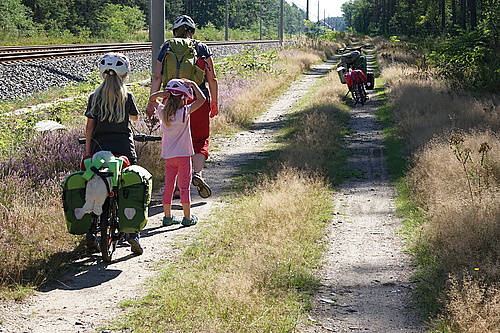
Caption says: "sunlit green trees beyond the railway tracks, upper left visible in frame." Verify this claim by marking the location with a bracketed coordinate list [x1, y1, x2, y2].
[0, 0, 344, 41]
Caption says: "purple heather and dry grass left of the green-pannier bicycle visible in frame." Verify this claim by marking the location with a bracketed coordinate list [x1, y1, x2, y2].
[0, 130, 84, 285]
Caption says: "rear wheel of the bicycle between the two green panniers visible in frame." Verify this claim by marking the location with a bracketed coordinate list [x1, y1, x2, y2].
[100, 198, 119, 262]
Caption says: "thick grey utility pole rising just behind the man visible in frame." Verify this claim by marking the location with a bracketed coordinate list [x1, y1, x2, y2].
[149, 0, 165, 75]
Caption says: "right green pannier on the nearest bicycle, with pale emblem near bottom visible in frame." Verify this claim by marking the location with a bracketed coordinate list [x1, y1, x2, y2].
[118, 165, 153, 233]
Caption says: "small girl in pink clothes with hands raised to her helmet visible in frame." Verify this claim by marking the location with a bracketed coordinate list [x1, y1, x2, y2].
[149, 79, 206, 226]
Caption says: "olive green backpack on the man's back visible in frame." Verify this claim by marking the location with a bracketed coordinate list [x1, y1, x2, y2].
[162, 38, 205, 85]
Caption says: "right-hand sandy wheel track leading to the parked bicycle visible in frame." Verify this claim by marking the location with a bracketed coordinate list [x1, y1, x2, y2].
[303, 74, 425, 333]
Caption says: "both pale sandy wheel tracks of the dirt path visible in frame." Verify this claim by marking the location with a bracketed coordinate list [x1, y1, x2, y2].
[0, 55, 426, 333]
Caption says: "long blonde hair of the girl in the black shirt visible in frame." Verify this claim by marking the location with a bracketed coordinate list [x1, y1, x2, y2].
[90, 71, 127, 123]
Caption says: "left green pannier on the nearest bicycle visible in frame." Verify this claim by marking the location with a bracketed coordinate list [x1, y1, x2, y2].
[62, 171, 92, 235]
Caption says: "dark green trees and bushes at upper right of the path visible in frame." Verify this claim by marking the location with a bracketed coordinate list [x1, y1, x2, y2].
[342, 0, 500, 92]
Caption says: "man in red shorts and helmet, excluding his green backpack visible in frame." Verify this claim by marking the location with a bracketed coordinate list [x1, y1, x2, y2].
[146, 15, 219, 198]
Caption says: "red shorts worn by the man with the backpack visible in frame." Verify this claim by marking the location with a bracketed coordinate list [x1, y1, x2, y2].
[190, 100, 210, 159]
